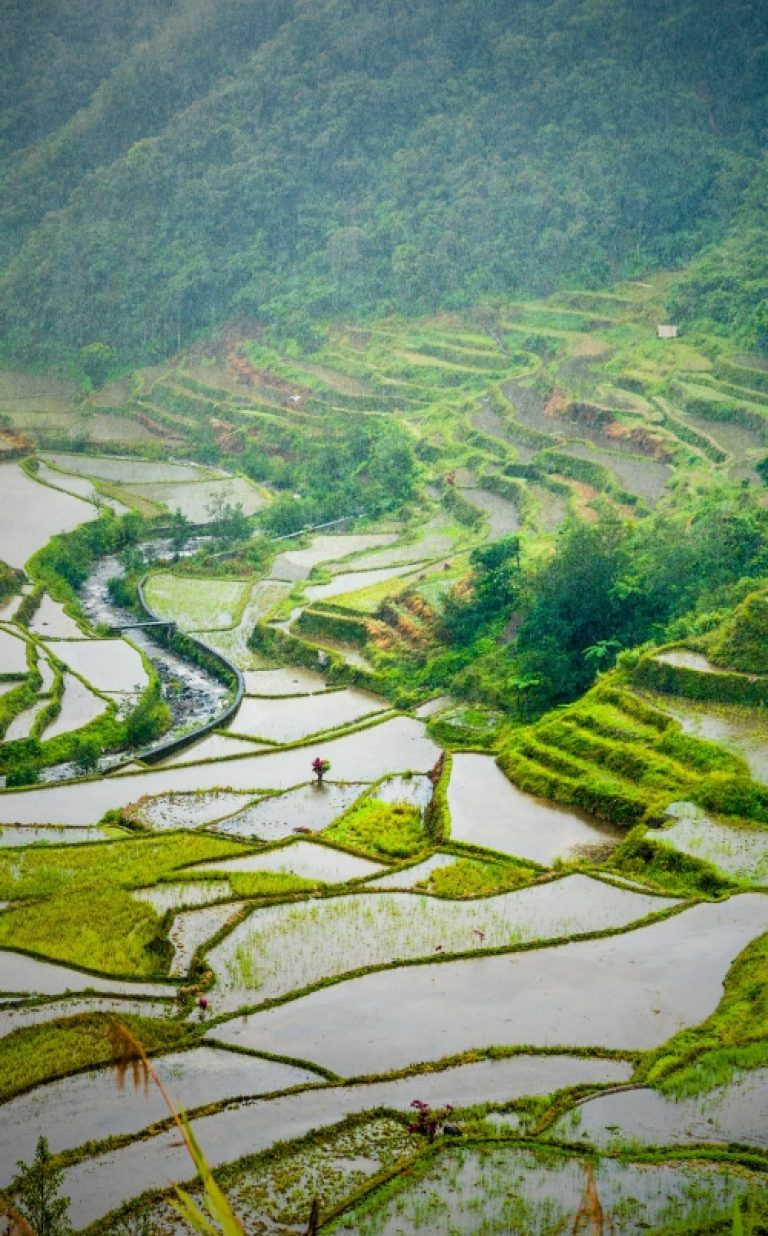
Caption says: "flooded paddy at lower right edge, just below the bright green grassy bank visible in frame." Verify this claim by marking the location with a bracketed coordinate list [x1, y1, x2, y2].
[552, 1069, 768, 1148]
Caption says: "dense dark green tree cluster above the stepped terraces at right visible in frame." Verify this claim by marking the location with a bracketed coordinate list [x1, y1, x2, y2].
[428, 489, 768, 712]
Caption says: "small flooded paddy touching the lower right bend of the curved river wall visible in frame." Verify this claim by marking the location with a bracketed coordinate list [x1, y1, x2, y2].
[229, 687, 388, 743]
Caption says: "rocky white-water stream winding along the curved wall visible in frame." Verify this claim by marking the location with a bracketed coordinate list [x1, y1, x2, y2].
[80, 543, 245, 761]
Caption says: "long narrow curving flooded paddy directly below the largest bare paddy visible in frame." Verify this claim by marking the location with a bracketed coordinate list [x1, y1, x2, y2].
[55, 1056, 628, 1227]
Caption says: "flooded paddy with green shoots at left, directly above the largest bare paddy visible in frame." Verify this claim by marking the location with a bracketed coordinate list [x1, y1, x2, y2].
[208, 875, 675, 1008]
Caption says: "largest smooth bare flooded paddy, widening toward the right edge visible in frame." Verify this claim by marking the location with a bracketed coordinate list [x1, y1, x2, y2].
[211, 894, 768, 1075]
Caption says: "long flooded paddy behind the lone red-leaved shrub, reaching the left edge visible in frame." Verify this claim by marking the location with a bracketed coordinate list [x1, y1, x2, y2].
[0, 717, 440, 824]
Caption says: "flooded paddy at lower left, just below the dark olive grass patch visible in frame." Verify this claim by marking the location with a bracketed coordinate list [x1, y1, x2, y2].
[0, 1047, 318, 1185]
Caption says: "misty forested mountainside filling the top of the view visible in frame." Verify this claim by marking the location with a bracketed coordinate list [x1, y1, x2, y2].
[0, 0, 768, 361]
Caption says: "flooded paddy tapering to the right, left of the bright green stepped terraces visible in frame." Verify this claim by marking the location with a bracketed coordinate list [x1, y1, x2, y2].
[448, 754, 622, 865]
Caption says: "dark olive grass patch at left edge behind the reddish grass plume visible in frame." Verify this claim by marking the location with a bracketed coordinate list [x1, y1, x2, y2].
[0, 1012, 194, 1103]
